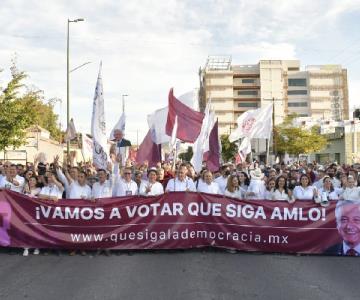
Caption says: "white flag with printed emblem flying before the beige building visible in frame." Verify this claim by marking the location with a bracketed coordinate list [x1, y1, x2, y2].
[229, 104, 272, 143]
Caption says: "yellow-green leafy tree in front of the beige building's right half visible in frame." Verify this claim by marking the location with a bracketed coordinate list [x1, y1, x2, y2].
[275, 115, 327, 156]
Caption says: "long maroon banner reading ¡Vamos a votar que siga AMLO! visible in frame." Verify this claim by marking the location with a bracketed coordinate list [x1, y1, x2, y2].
[0, 191, 360, 255]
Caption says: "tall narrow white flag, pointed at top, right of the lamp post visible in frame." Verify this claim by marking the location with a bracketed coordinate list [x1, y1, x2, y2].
[91, 63, 108, 169]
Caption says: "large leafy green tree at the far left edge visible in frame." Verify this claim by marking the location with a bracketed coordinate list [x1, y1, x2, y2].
[0, 61, 60, 150]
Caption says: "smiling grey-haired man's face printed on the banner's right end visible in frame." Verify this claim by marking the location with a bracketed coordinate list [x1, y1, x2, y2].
[338, 204, 360, 247]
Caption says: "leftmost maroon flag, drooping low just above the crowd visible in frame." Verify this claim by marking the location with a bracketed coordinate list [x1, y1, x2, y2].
[136, 129, 161, 167]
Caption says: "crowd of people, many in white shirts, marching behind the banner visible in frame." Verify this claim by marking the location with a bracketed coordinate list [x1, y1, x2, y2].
[0, 139, 360, 256]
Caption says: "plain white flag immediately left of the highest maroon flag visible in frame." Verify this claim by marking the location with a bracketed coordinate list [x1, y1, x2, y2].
[147, 107, 171, 144]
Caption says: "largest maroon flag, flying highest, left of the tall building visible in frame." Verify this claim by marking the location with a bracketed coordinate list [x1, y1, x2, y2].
[166, 89, 204, 143]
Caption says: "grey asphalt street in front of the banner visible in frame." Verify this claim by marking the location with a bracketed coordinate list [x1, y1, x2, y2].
[0, 250, 360, 300]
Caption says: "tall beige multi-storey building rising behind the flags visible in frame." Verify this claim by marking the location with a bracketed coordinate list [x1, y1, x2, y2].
[199, 56, 349, 134]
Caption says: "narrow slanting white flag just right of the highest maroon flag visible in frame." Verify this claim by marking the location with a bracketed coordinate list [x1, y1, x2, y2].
[191, 101, 215, 172]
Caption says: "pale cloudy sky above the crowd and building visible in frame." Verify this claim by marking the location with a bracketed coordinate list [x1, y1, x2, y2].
[0, 0, 360, 144]
